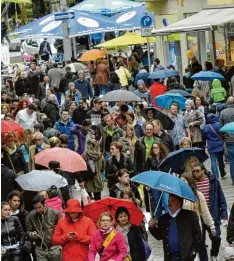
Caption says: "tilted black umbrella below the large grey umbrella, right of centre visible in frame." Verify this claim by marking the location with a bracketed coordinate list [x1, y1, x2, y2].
[142, 107, 175, 130]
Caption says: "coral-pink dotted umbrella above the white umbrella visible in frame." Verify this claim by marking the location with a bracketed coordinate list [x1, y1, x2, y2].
[35, 148, 87, 172]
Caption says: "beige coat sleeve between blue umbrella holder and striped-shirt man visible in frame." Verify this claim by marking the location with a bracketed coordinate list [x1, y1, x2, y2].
[183, 190, 215, 229]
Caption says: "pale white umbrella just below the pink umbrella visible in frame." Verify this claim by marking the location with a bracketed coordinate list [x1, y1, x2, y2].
[16, 170, 68, 191]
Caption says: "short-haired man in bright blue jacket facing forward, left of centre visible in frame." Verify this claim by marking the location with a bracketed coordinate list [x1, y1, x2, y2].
[54, 110, 75, 150]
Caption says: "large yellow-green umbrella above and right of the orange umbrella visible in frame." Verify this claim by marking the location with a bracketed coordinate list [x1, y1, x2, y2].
[96, 33, 156, 48]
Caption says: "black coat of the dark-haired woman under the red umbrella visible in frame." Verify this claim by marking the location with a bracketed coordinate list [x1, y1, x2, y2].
[128, 225, 146, 261]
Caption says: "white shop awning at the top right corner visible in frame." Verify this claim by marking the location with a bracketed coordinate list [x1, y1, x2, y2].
[152, 7, 234, 35]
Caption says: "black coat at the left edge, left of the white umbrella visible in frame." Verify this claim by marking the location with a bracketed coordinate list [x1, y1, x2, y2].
[1, 164, 19, 201]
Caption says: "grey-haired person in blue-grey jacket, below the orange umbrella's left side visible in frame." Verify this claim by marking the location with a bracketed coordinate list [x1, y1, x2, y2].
[74, 70, 93, 100]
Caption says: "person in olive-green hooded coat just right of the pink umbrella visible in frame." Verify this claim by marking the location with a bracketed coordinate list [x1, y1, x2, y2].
[82, 139, 105, 200]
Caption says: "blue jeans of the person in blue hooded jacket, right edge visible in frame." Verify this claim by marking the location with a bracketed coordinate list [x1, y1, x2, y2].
[210, 151, 226, 179]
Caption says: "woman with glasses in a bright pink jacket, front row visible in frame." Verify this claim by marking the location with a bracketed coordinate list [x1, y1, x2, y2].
[89, 212, 127, 261]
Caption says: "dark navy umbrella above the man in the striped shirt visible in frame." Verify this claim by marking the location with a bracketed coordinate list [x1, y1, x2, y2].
[159, 148, 209, 174]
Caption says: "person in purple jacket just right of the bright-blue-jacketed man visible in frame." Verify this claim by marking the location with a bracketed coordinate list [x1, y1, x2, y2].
[71, 119, 93, 154]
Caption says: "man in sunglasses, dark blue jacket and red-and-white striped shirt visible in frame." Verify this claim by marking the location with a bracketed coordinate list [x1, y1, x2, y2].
[193, 163, 228, 261]
